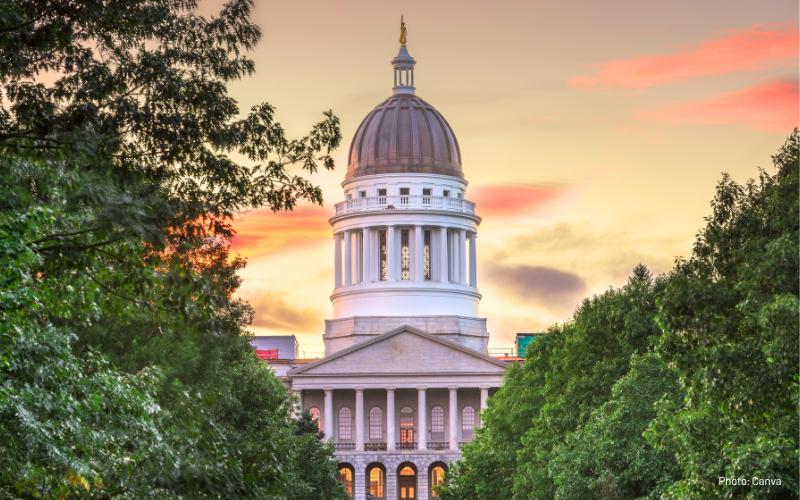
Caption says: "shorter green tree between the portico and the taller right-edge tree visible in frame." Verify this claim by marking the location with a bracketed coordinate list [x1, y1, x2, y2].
[444, 266, 663, 498]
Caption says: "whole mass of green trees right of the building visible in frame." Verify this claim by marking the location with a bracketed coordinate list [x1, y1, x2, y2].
[443, 130, 800, 499]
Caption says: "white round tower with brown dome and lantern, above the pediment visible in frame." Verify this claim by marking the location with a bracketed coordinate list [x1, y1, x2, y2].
[325, 26, 488, 355]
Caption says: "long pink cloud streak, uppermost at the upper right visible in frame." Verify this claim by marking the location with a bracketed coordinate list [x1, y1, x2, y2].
[570, 25, 798, 90]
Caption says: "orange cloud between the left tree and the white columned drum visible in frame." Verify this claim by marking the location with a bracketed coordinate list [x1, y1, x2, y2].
[231, 206, 332, 257]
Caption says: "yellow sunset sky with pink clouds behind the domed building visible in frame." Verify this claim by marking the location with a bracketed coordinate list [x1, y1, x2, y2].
[216, 0, 798, 355]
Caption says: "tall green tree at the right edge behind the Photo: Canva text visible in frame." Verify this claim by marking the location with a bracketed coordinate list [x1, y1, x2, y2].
[648, 130, 800, 498]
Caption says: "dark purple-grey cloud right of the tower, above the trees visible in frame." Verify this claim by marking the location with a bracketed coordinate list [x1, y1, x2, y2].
[487, 264, 586, 308]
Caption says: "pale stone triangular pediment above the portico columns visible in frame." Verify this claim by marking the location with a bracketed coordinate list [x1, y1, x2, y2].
[292, 326, 506, 375]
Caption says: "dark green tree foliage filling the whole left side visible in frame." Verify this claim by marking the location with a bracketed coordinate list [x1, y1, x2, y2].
[0, 0, 343, 498]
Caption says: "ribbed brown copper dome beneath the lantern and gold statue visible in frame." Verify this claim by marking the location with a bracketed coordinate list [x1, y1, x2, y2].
[345, 92, 464, 180]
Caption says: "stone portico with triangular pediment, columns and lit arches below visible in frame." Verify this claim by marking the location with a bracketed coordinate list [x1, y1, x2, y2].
[291, 326, 506, 499]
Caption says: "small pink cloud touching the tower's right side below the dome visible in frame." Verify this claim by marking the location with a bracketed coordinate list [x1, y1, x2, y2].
[469, 184, 564, 216]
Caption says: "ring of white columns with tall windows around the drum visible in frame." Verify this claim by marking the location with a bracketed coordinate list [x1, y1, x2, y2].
[334, 224, 478, 288]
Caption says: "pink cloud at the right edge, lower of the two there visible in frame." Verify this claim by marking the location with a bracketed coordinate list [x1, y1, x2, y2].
[639, 80, 798, 133]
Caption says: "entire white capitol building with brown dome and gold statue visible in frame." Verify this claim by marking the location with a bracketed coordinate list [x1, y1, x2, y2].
[253, 20, 520, 500]
